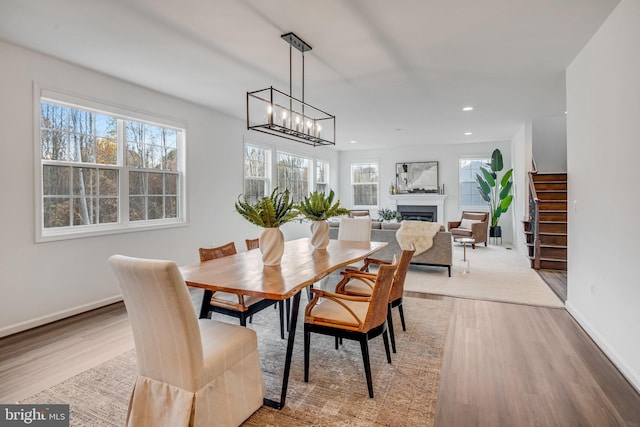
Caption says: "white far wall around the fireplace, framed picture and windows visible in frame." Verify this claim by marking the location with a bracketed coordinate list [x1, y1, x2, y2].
[339, 141, 513, 243]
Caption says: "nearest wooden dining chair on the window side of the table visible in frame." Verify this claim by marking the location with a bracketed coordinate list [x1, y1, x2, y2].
[198, 242, 285, 338]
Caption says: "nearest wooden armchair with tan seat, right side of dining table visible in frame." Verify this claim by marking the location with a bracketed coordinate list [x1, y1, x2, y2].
[304, 260, 397, 398]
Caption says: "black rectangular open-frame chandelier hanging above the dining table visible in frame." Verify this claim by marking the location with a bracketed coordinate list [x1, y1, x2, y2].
[247, 33, 336, 147]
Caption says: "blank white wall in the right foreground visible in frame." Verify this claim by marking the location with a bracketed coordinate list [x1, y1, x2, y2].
[567, 0, 640, 390]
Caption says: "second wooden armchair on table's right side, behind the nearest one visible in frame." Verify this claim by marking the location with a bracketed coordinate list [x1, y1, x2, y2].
[336, 245, 416, 353]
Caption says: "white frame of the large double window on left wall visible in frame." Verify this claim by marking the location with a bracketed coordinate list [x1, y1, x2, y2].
[33, 87, 188, 243]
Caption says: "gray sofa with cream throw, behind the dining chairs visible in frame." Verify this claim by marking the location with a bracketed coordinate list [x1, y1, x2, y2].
[329, 221, 453, 277]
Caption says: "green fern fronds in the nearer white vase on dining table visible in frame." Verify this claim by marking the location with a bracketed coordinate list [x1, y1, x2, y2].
[235, 187, 298, 228]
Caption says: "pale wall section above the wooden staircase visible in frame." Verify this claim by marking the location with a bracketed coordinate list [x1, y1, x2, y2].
[533, 115, 567, 172]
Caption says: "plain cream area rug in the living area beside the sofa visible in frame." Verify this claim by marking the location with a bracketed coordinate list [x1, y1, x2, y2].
[405, 243, 564, 308]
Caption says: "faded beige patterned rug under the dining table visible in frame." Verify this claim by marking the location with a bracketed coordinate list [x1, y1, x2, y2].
[21, 294, 453, 427]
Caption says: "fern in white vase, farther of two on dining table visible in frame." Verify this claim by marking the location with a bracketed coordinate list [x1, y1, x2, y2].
[296, 190, 349, 249]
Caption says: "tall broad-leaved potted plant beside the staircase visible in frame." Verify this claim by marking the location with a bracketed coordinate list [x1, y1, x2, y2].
[476, 148, 513, 237]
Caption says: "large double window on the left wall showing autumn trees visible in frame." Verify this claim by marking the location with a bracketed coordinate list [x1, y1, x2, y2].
[37, 97, 184, 244]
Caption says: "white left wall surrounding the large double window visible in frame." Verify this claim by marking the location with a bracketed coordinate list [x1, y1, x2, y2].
[0, 41, 337, 336]
